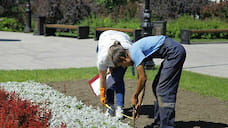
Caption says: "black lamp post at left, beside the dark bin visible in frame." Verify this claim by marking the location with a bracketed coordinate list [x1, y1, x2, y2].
[24, 0, 32, 33]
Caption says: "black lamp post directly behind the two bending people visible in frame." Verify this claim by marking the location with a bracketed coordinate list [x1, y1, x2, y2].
[140, 0, 155, 69]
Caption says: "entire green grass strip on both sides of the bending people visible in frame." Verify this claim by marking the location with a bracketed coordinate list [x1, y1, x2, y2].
[0, 67, 228, 101]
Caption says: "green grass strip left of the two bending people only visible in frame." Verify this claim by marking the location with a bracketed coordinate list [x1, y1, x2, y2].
[0, 67, 97, 82]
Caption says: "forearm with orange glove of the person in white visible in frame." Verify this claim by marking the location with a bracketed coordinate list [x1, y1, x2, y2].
[99, 70, 107, 104]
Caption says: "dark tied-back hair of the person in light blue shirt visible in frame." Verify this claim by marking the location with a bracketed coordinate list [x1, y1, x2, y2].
[108, 41, 127, 66]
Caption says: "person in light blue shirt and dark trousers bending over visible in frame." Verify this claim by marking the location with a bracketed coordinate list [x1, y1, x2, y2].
[109, 35, 186, 128]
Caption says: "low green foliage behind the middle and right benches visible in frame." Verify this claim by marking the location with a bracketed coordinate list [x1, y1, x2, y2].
[78, 15, 228, 39]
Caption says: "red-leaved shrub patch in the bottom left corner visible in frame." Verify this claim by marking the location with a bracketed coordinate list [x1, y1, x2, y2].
[0, 89, 51, 128]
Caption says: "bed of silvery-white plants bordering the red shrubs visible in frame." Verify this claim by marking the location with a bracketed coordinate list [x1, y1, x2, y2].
[0, 81, 130, 128]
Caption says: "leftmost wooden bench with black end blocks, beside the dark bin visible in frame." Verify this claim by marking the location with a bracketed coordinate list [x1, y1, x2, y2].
[44, 24, 89, 39]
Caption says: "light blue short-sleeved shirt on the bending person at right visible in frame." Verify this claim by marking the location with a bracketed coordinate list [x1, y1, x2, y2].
[129, 35, 165, 67]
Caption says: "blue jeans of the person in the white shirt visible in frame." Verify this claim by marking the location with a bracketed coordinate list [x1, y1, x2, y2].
[106, 67, 127, 107]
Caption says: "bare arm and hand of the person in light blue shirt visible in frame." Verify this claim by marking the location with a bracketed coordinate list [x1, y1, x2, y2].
[131, 63, 147, 107]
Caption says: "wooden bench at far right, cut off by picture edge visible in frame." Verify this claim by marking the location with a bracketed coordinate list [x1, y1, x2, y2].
[180, 29, 228, 44]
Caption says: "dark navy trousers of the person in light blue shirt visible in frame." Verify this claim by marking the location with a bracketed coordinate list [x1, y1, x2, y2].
[150, 38, 186, 128]
